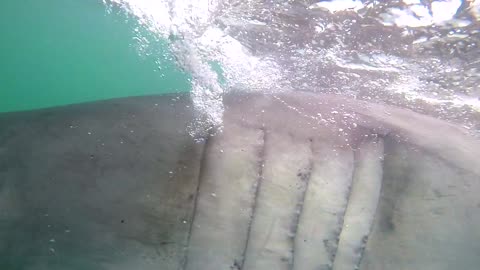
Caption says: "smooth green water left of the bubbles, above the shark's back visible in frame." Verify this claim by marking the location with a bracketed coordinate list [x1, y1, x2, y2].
[0, 0, 190, 112]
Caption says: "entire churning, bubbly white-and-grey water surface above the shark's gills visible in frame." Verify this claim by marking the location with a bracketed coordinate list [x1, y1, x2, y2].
[105, 0, 480, 131]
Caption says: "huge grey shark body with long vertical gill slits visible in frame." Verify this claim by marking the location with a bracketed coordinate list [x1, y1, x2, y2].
[0, 93, 480, 270]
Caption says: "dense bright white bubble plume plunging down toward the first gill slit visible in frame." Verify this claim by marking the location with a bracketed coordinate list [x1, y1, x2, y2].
[105, 0, 280, 130]
